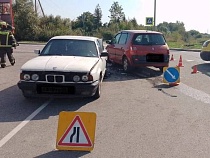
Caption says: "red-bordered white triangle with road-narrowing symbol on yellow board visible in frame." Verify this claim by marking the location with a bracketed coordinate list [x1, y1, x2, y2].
[58, 115, 92, 147]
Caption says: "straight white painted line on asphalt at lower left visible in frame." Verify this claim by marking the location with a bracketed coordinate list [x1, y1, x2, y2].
[0, 99, 51, 148]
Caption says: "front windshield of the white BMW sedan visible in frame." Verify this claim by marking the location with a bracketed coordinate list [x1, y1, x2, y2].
[40, 39, 98, 57]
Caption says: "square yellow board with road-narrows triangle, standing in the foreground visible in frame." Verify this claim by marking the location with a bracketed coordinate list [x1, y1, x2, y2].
[56, 111, 96, 151]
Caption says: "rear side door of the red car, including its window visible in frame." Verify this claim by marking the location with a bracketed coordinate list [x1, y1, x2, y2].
[115, 33, 128, 64]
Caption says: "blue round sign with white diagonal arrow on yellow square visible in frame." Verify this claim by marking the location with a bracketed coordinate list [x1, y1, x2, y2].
[163, 67, 180, 83]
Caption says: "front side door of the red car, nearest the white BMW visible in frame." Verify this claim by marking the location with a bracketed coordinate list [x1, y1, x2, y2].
[106, 33, 121, 62]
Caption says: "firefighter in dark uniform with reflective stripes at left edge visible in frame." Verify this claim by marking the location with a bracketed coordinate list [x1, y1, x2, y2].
[0, 22, 17, 68]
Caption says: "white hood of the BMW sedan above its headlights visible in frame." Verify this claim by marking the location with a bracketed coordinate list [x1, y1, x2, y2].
[21, 56, 98, 72]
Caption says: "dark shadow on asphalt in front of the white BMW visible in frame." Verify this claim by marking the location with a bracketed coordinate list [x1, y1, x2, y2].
[0, 85, 94, 122]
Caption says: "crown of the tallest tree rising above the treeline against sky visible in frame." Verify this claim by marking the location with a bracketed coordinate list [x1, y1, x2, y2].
[109, 2, 125, 23]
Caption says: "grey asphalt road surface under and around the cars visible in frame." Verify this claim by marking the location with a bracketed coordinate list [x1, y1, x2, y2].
[0, 45, 210, 158]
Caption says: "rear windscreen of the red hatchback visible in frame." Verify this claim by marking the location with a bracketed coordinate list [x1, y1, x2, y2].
[132, 34, 166, 45]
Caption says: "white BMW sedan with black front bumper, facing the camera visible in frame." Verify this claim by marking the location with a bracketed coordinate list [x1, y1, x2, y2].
[18, 36, 108, 98]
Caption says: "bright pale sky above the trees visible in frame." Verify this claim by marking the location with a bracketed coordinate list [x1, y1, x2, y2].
[37, 0, 210, 33]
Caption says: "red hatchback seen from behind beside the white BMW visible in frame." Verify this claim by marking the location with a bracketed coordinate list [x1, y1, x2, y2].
[106, 30, 169, 72]
